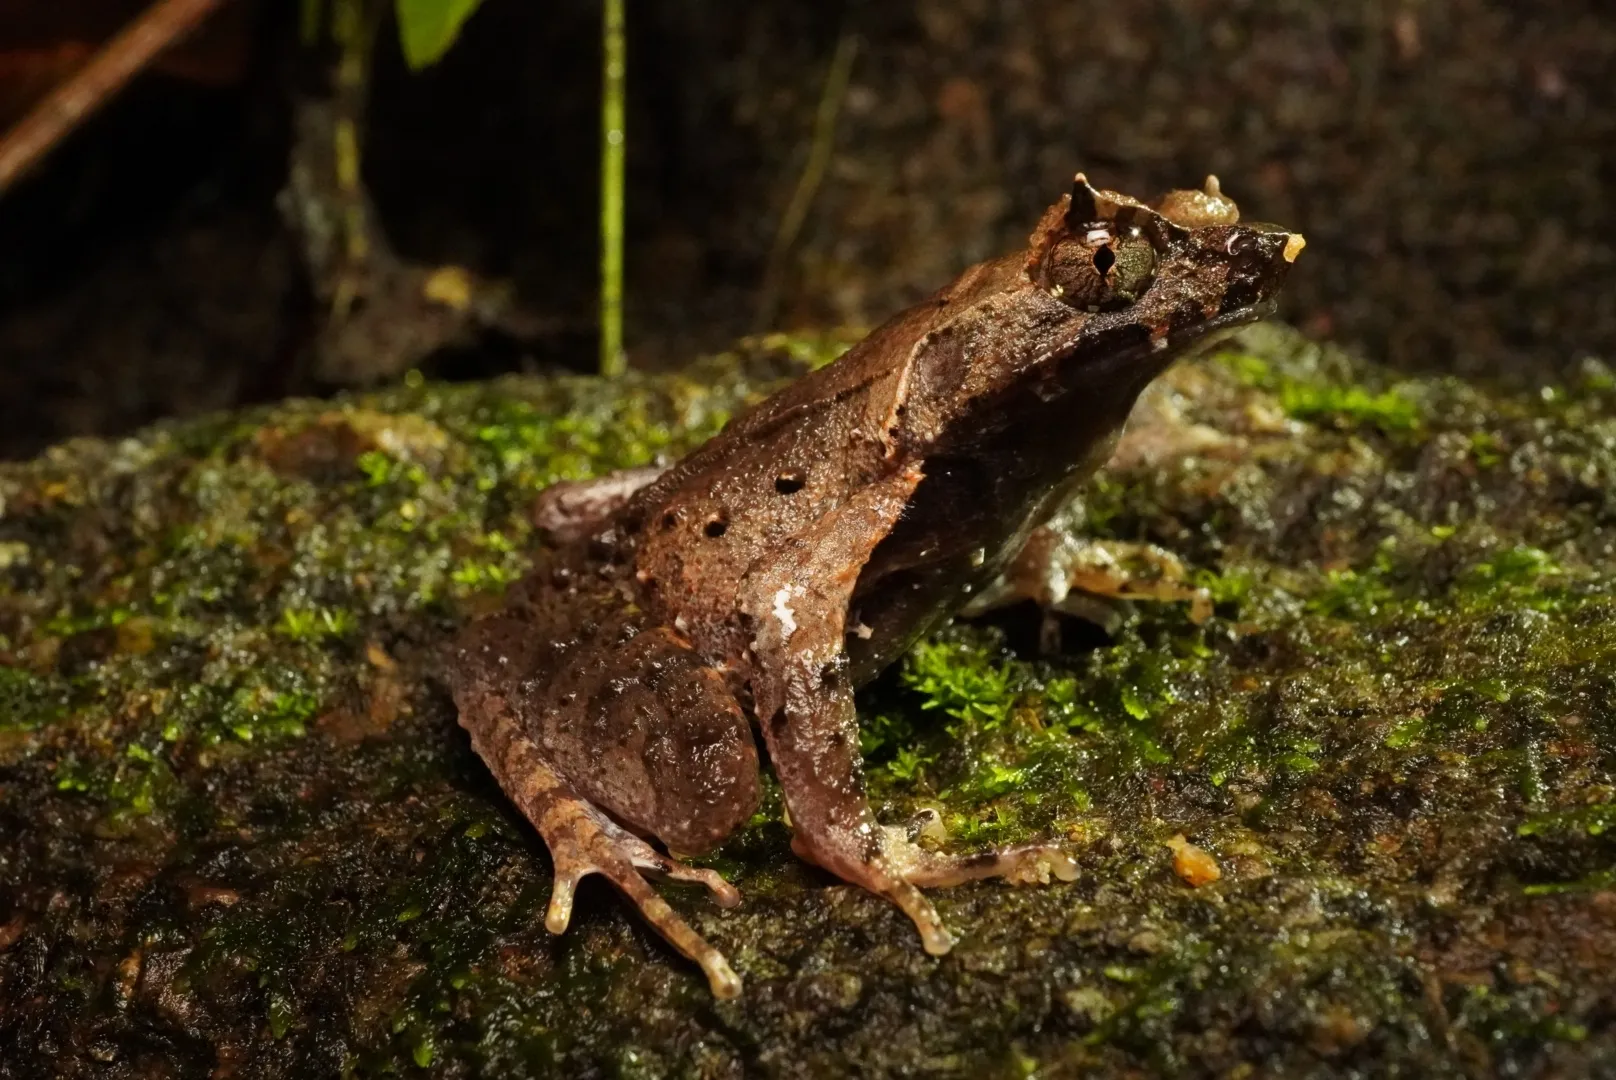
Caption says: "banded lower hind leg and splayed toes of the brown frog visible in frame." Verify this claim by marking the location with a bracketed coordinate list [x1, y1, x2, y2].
[461, 694, 740, 998]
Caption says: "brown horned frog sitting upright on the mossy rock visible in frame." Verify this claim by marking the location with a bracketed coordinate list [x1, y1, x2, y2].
[448, 173, 1304, 999]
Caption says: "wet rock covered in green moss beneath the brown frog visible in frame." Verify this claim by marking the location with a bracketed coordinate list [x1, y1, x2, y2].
[0, 328, 1616, 1077]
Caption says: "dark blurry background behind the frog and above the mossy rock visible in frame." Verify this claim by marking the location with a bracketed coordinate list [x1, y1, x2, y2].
[0, 0, 1616, 458]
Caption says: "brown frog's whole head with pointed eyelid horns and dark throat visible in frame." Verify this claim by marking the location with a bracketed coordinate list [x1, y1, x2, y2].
[902, 173, 1302, 472]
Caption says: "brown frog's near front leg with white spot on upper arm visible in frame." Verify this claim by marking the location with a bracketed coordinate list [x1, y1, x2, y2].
[743, 470, 1076, 956]
